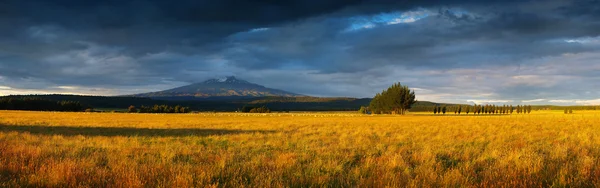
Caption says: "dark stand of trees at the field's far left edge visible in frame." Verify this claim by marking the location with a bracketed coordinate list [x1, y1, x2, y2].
[0, 97, 84, 112]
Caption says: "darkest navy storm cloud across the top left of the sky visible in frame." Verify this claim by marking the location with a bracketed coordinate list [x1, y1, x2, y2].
[0, 0, 524, 55]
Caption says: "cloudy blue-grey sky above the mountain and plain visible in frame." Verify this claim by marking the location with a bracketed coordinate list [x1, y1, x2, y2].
[0, 0, 600, 105]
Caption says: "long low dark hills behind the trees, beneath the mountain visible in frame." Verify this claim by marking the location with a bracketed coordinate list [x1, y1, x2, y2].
[0, 95, 466, 112]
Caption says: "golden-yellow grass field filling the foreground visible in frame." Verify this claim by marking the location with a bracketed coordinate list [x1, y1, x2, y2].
[0, 111, 600, 187]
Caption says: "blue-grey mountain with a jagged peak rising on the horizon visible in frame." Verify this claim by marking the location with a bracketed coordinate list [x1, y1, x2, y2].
[133, 76, 305, 100]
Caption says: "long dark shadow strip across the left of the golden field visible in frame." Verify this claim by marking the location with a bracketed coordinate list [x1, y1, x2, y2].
[0, 125, 275, 137]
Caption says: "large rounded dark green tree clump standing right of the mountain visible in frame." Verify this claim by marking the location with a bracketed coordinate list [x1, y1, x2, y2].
[369, 83, 416, 115]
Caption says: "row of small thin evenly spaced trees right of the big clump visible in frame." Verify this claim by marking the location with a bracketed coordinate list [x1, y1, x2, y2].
[432, 104, 532, 114]
